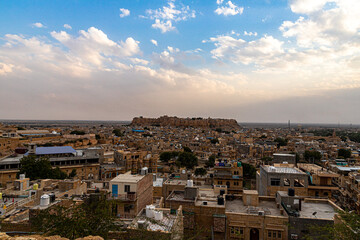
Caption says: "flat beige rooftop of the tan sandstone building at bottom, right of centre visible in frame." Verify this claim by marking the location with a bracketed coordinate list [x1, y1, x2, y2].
[225, 199, 282, 216]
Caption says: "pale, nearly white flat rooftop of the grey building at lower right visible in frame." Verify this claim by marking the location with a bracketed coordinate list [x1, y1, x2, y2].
[300, 202, 336, 220]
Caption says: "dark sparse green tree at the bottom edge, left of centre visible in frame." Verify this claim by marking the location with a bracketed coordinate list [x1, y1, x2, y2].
[31, 196, 117, 239]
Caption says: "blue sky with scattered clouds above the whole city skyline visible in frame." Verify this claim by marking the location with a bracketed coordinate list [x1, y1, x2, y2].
[0, 0, 360, 124]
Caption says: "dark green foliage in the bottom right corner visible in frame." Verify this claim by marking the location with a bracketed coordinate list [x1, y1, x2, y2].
[305, 211, 360, 240]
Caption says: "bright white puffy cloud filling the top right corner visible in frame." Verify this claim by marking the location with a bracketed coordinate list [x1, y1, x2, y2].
[279, 0, 360, 48]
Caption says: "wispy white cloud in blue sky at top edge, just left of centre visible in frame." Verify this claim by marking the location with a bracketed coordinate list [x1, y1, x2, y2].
[146, 0, 196, 33]
